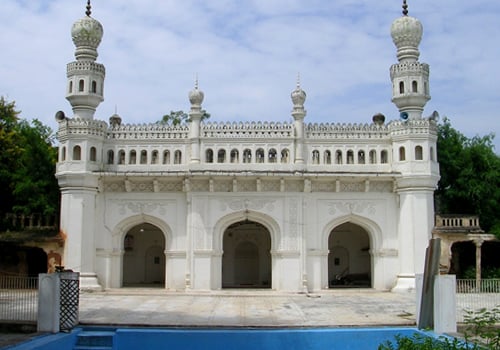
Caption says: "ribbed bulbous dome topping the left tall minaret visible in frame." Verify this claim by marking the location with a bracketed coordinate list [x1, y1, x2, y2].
[71, 16, 104, 60]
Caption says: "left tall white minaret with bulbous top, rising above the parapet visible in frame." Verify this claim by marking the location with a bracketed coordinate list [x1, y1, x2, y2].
[66, 0, 106, 119]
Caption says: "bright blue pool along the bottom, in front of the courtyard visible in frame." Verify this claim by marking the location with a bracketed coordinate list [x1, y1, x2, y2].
[9, 327, 446, 350]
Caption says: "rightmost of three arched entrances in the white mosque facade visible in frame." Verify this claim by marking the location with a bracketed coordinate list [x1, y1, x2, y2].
[328, 222, 372, 288]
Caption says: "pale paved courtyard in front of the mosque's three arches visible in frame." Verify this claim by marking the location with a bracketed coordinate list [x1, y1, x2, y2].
[80, 288, 415, 327]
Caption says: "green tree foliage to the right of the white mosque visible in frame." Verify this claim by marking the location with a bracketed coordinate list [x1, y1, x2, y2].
[436, 118, 500, 237]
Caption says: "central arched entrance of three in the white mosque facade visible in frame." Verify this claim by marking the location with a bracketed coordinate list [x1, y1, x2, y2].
[222, 220, 272, 288]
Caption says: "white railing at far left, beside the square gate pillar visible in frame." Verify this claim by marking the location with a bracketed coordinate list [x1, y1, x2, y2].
[0, 276, 38, 323]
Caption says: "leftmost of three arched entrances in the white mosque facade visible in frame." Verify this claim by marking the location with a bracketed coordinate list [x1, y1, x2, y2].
[123, 223, 165, 287]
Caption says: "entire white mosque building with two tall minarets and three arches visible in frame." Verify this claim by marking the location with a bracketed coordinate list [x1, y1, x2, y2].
[56, 1, 439, 292]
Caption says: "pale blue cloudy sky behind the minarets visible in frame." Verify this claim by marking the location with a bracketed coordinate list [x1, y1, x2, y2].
[0, 0, 500, 153]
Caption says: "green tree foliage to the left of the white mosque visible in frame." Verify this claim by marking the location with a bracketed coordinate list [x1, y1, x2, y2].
[0, 97, 59, 224]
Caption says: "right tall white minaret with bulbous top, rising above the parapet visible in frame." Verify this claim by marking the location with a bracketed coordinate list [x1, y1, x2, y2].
[391, 0, 431, 120]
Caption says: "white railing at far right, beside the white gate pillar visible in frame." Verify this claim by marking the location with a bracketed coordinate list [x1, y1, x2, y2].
[457, 279, 500, 322]
